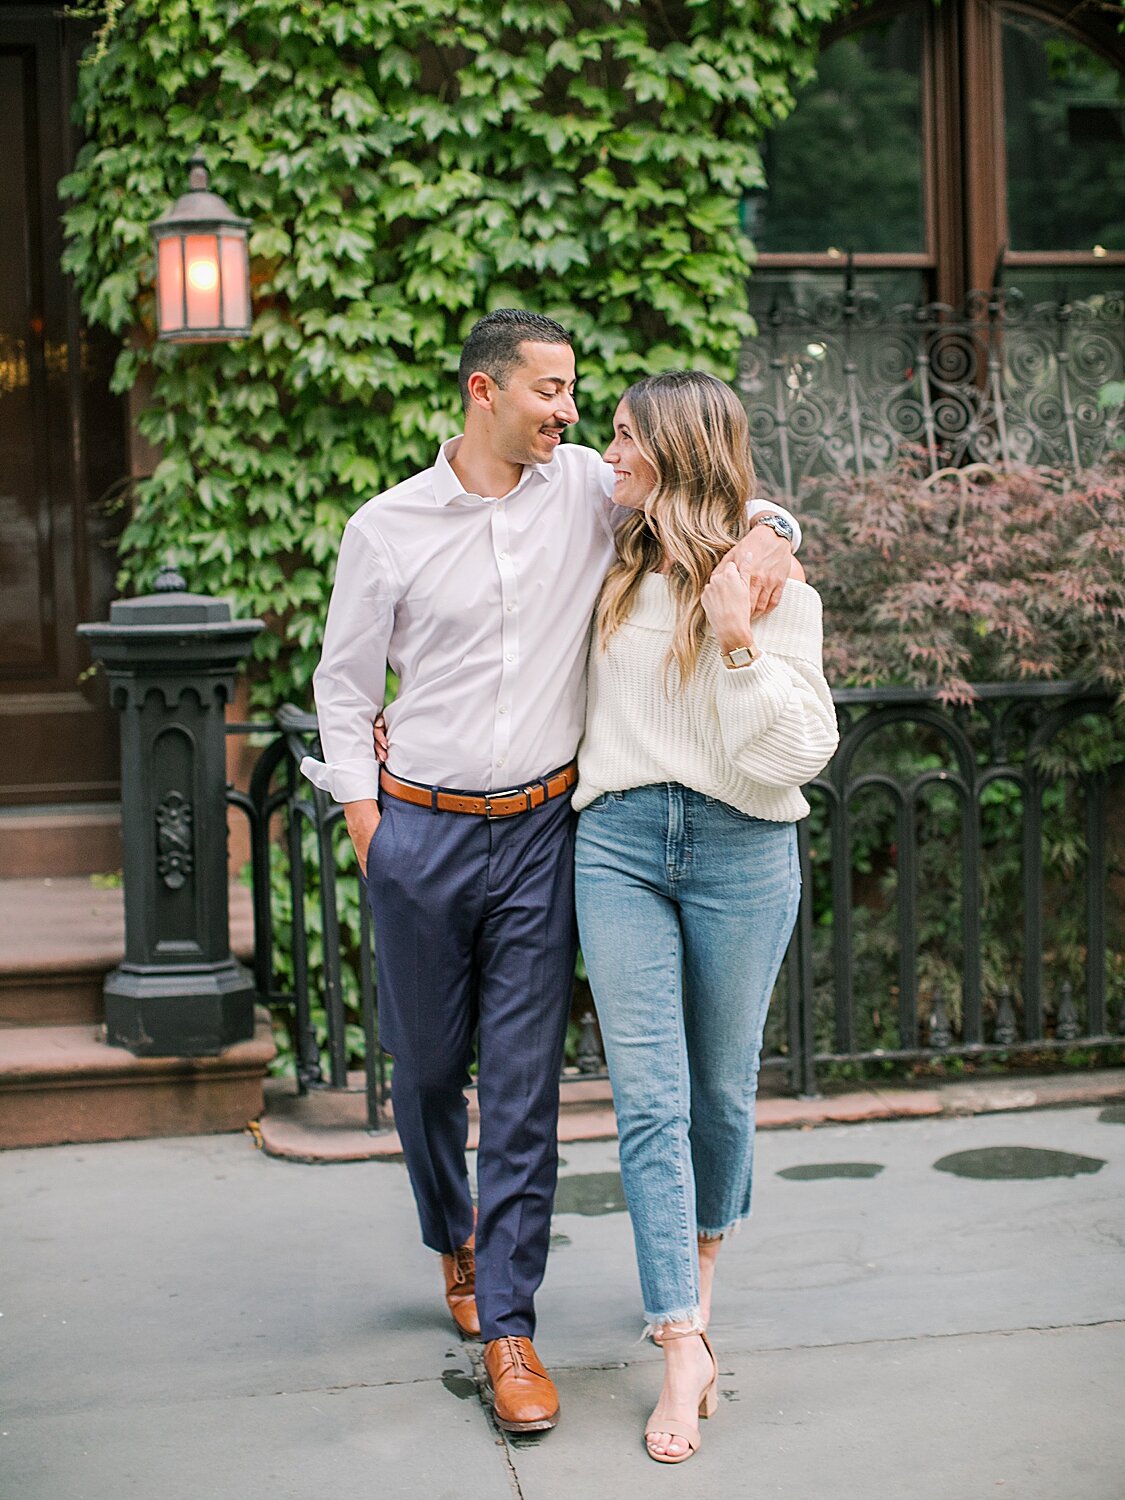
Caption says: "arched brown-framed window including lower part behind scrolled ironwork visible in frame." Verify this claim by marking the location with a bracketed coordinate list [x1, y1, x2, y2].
[740, 0, 1125, 494]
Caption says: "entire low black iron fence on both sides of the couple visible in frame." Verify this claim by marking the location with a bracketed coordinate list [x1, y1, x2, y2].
[228, 683, 1125, 1128]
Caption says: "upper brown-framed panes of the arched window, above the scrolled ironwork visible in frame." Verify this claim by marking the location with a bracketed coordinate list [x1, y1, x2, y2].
[744, 0, 1125, 305]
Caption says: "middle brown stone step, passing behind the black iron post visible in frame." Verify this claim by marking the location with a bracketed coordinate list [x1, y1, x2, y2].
[0, 876, 254, 1029]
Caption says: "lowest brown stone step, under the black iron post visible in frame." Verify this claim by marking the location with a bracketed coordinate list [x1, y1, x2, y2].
[0, 1008, 275, 1148]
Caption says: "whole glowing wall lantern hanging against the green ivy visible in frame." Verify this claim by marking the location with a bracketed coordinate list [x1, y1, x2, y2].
[152, 156, 251, 344]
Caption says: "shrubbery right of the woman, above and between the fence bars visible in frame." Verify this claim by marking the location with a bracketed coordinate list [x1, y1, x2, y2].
[786, 456, 1125, 1068]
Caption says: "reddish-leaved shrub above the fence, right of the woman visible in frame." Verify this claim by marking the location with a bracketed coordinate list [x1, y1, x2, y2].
[801, 455, 1125, 702]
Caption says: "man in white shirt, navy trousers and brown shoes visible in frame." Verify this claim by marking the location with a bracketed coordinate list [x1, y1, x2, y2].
[302, 309, 795, 1431]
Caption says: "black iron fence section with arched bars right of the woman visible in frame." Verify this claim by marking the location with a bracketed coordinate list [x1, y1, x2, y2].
[786, 683, 1125, 1094]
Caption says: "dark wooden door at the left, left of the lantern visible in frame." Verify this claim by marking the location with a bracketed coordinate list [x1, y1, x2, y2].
[0, 6, 126, 806]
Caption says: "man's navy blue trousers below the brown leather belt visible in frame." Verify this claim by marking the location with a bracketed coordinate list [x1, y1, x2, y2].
[368, 795, 578, 1340]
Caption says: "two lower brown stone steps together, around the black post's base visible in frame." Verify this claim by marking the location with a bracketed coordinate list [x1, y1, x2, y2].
[0, 876, 275, 1148]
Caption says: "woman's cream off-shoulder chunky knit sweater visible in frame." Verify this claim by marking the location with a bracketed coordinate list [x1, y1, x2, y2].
[575, 573, 839, 822]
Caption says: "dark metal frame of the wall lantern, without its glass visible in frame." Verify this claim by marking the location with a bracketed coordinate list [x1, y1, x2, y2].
[152, 153, 252, 344]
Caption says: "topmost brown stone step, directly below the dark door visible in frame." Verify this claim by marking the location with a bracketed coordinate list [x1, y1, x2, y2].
[0, 803, 122, 881]
